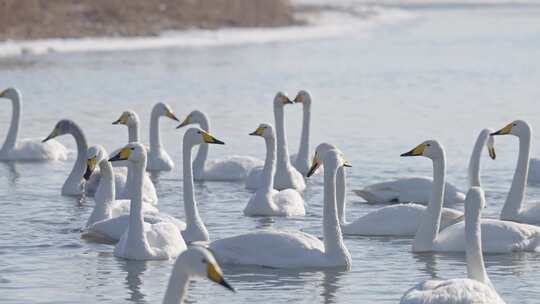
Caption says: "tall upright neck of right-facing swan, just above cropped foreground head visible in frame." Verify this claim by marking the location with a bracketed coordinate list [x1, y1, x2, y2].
[183, 141, 209, 242]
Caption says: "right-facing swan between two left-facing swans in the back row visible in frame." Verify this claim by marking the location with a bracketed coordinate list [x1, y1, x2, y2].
[146, 102, 179, 171]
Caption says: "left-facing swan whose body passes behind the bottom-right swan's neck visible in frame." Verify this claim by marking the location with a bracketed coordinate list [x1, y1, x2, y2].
[402, 140, 540, 253]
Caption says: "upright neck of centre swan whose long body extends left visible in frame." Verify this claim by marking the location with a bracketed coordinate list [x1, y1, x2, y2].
[323, 163, 349, 257]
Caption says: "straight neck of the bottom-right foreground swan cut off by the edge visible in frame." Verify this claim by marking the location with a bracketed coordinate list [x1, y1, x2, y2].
[465, 204, 491, 286]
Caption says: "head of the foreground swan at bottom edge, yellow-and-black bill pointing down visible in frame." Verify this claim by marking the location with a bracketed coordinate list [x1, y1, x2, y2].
[169, 246, 235, 292]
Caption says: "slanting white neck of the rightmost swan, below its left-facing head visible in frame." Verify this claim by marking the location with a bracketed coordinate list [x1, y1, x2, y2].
[501, 130, 531, 219]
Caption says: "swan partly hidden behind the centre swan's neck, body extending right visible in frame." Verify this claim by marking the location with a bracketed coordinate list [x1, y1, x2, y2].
[308, 143, 463, 236]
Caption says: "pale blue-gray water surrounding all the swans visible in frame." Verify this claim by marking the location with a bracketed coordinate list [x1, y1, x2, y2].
[0, 2, 540, 303]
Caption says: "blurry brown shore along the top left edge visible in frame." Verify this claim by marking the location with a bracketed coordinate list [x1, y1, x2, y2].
[0, 0, 297, 41]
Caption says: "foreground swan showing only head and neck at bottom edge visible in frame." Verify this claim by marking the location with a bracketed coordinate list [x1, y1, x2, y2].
[163, 246, 235, 304]
